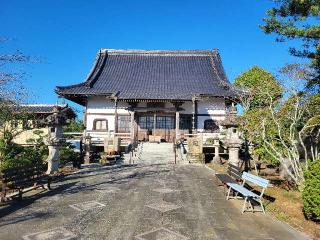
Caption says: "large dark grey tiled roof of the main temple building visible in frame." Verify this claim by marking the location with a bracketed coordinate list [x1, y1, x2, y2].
[56, 50, 234, 103]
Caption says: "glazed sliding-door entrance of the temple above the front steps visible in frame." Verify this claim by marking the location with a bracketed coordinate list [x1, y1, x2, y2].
[137, 113, 175, 142]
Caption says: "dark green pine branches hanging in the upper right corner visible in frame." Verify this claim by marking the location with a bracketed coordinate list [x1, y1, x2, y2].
[261, 0, 320, 89]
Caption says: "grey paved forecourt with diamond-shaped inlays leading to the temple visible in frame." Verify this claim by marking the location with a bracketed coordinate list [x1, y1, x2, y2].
[0, 143, 308, 240]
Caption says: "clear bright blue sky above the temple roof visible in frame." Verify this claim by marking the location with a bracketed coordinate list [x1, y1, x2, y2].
[0, 0, 300, 114]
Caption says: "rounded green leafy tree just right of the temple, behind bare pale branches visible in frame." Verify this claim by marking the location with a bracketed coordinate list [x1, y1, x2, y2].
[235, 66, 282, 165]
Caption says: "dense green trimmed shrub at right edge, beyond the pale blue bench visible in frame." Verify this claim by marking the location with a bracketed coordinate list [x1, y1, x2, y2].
[302, 158, 320, 222]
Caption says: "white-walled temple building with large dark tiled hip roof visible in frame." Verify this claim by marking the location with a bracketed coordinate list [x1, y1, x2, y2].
[56, 49, 236, 146]
